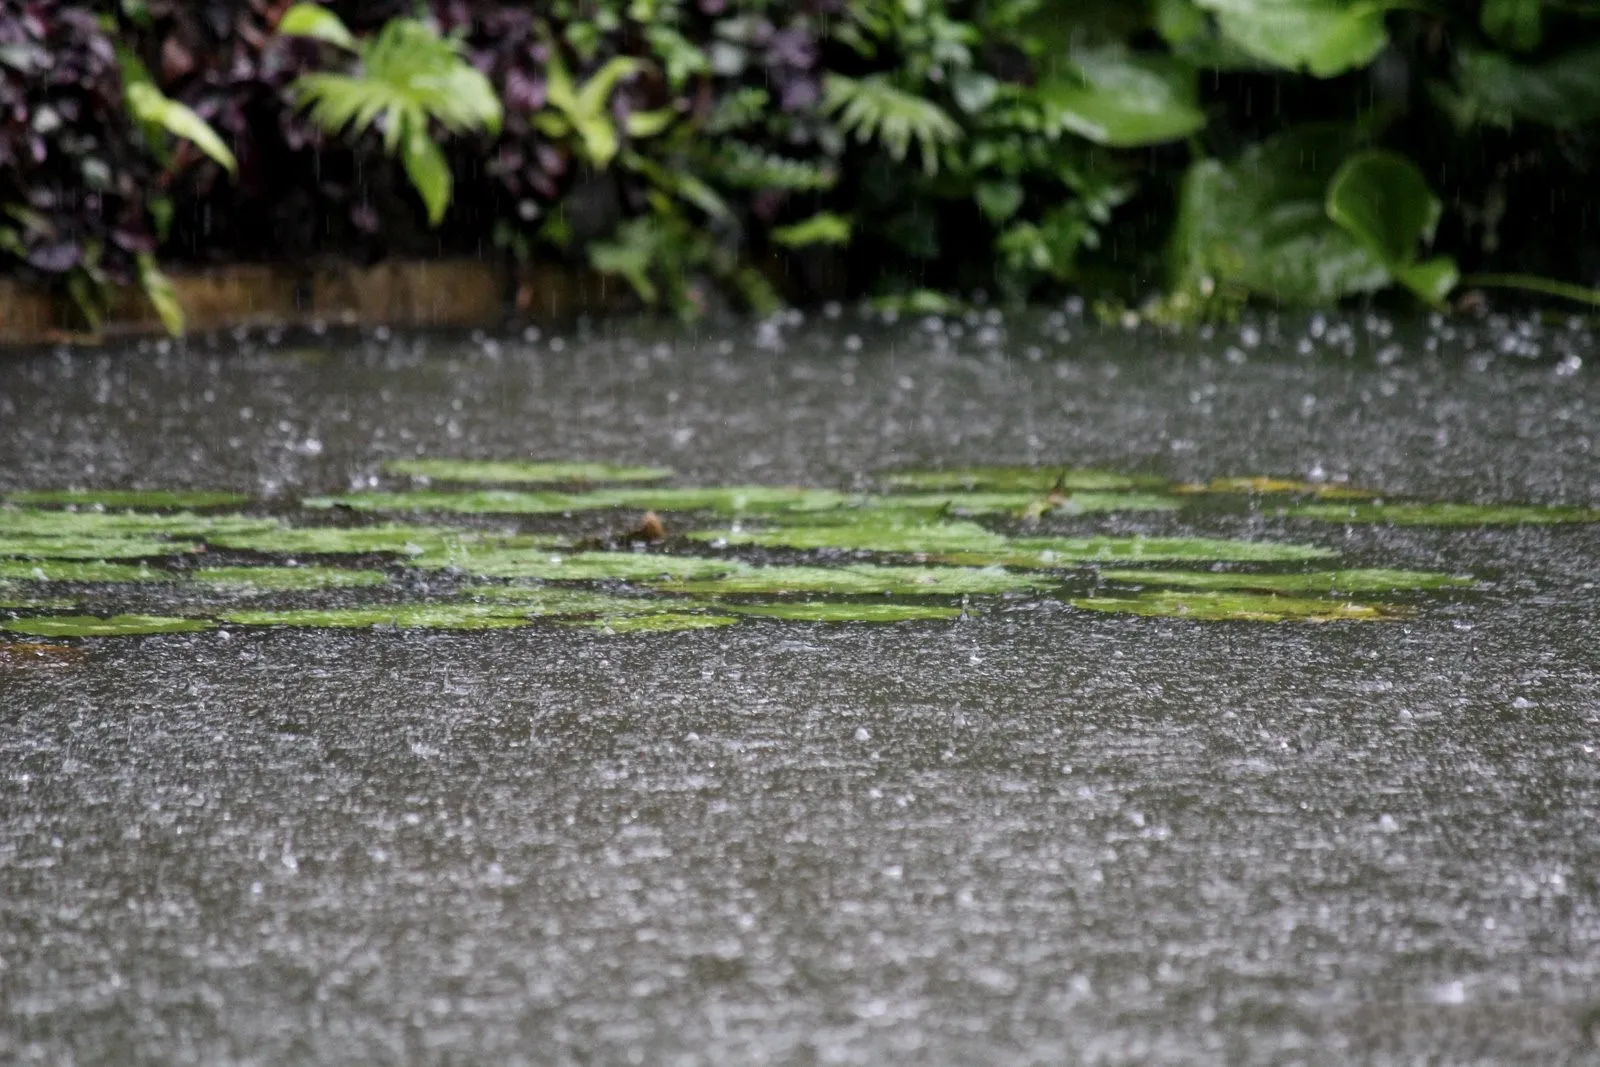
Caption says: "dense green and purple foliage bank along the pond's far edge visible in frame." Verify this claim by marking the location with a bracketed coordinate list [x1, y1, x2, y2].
[0, 0, 1600, 330]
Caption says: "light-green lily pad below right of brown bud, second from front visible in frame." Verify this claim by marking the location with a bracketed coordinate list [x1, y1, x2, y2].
[650, 563, 1056, 597]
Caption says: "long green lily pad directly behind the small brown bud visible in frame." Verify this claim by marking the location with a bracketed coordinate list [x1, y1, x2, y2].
[306, 485, 850, 515]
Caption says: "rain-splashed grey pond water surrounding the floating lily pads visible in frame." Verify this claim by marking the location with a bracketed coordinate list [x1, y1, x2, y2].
[0, 303, 1600, 1065]
